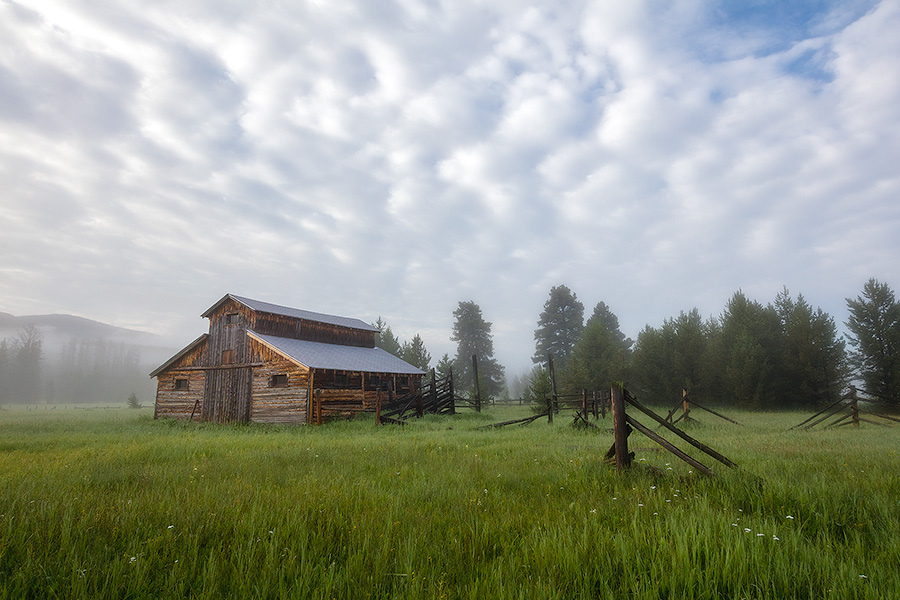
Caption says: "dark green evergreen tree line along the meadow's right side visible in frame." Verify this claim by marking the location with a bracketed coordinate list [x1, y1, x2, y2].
[522, 279, 900, 410]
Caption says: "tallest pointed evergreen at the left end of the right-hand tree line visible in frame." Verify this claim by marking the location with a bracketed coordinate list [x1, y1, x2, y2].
[531, 285, 584, 368]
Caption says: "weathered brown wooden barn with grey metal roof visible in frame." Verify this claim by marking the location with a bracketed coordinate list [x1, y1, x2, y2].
[150, 294, 424, 423]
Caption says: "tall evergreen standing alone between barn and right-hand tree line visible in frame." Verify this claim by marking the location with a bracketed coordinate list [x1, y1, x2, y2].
[450, 301, 503, 399]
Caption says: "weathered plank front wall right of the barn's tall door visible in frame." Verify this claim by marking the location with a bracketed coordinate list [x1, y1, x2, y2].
[250, 340, 309, 424]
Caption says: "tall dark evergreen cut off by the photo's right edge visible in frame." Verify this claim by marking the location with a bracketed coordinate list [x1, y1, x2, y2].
[846, 278, 900, 404]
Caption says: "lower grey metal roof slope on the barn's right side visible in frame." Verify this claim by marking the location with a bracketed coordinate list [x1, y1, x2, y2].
[247, 331, 424, 375]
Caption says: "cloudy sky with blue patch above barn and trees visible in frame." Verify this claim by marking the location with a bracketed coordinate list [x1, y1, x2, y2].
[0, 0, 900, 375]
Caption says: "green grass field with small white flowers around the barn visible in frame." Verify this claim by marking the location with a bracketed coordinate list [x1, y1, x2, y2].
[0, 407, 900, 600]
